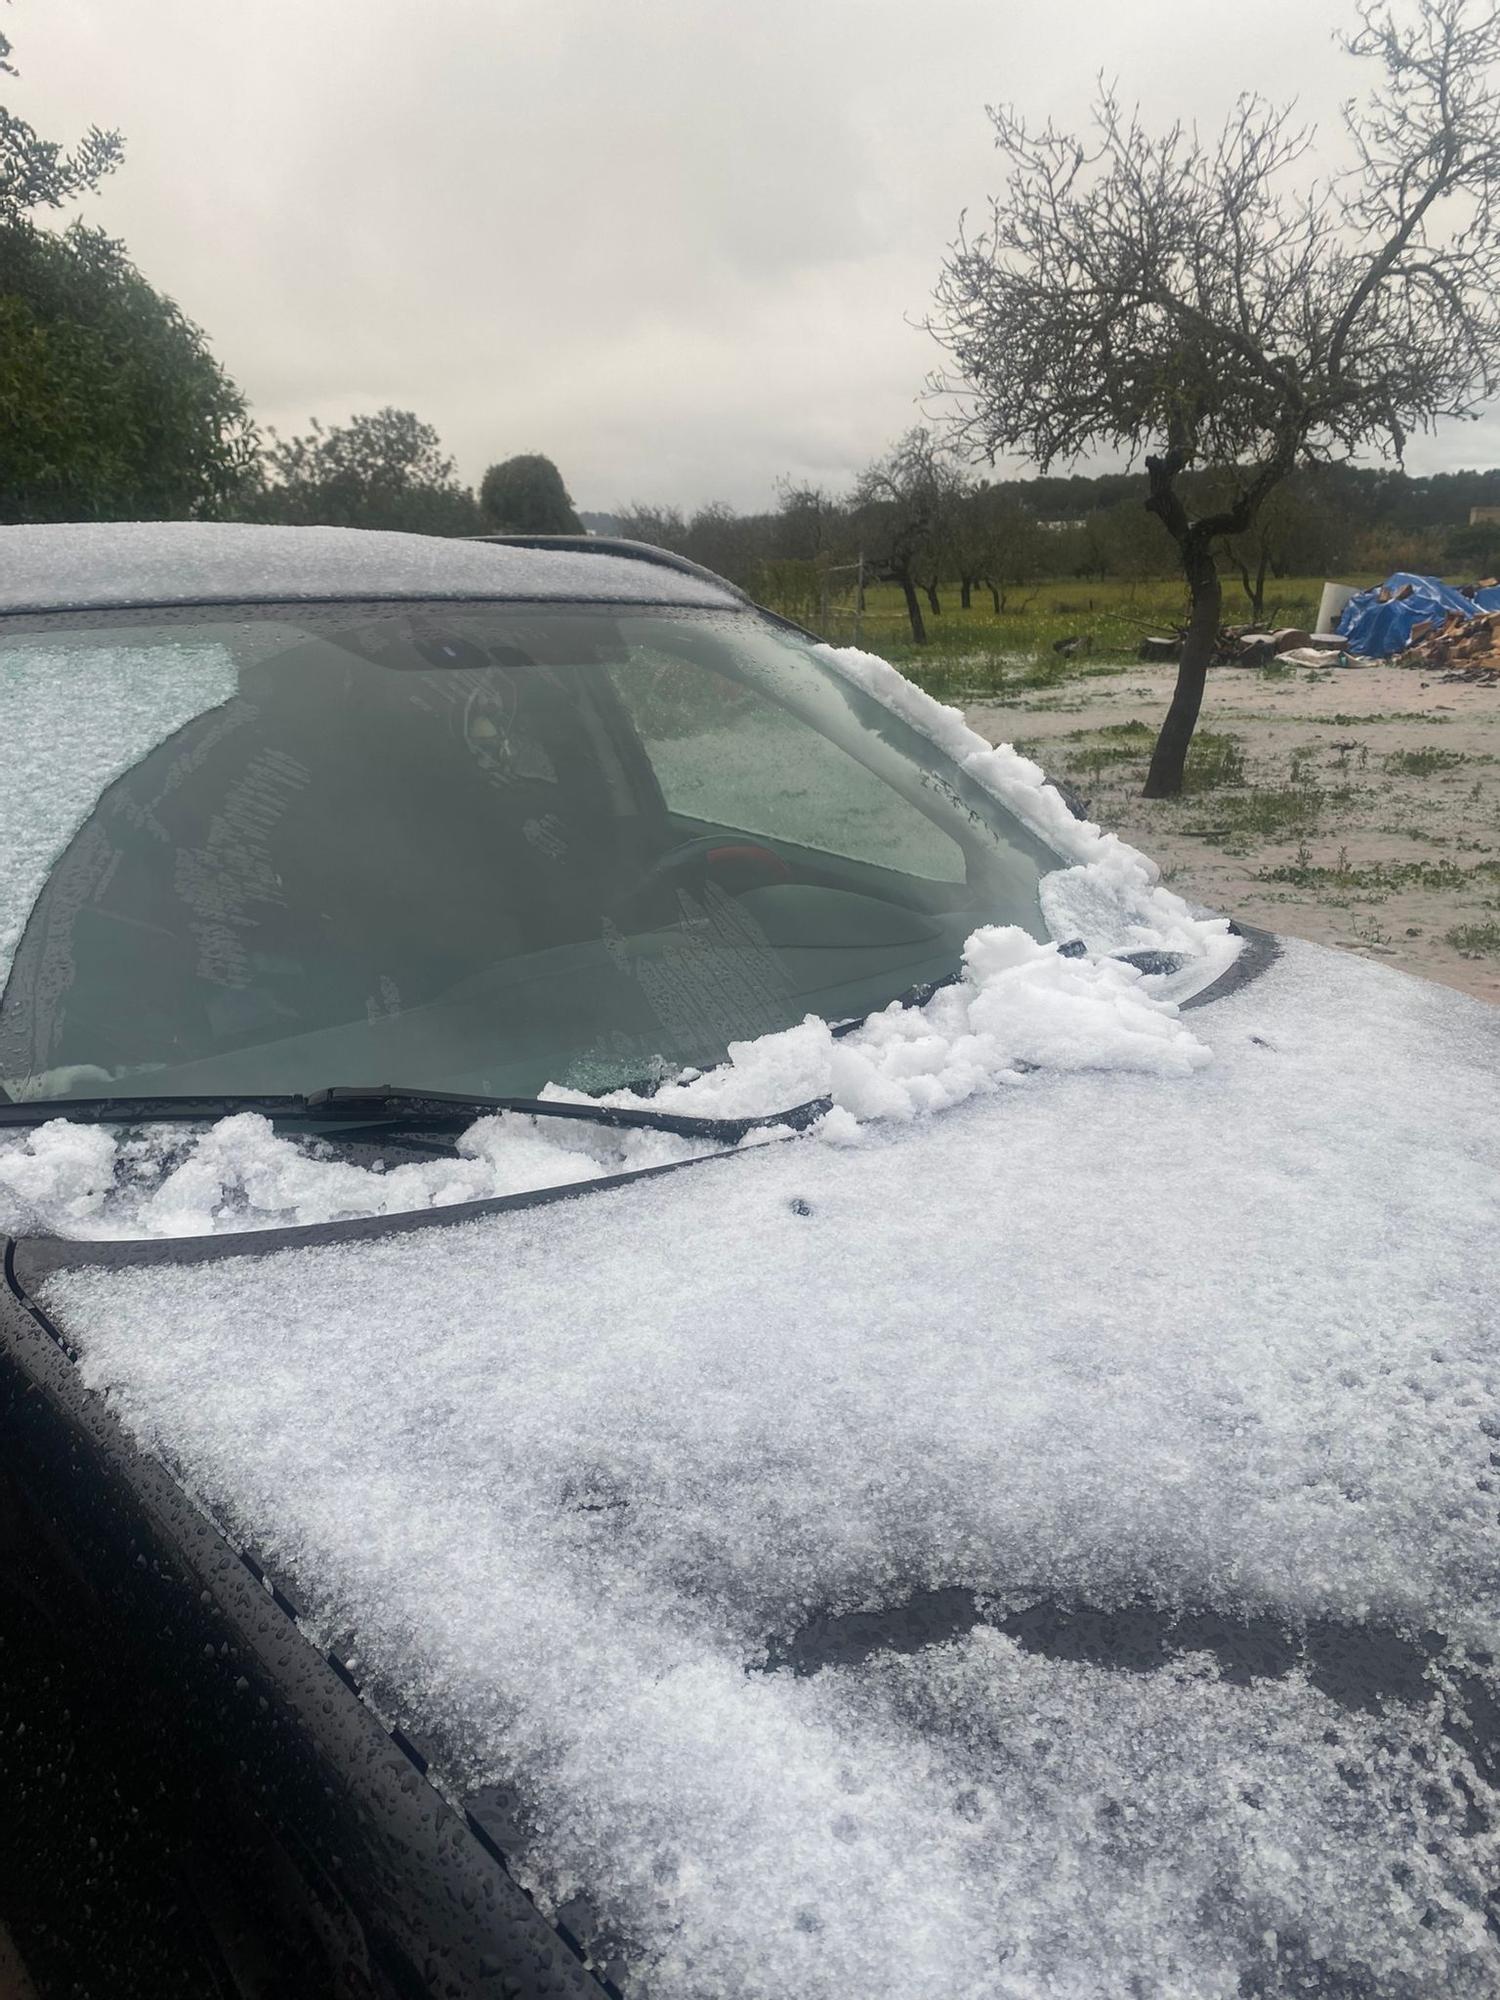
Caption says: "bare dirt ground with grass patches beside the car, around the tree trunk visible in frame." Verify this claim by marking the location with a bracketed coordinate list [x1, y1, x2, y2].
[968, 666, 1500, 1002]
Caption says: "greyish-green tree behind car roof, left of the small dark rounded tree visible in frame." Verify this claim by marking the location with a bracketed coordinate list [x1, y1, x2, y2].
[246, 408, 482, 534]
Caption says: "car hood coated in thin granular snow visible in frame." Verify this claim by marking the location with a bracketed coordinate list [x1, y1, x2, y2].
[29, 944, 1500, 2000]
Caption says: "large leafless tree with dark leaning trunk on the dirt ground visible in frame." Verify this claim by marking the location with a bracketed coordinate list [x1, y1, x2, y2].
[932, 0, 1500, 798]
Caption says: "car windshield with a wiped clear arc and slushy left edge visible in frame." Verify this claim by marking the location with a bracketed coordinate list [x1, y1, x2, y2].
[0, 604, 1058, 1098]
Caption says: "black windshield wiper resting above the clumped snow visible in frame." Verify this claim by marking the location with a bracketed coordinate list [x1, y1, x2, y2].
[0, 1084, 832, 1146]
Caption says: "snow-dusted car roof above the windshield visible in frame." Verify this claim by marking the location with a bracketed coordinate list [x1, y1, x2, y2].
[0, 520, 746, 614]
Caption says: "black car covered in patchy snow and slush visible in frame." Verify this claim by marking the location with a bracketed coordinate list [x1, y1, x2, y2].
[0, 526, 1500, 2000]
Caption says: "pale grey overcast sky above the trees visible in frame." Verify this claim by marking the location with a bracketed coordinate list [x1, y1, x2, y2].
[6, 0, 1500, 508]
